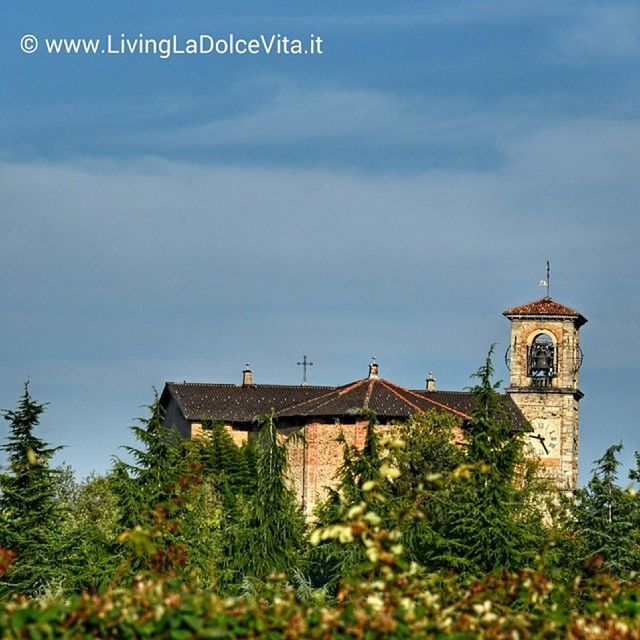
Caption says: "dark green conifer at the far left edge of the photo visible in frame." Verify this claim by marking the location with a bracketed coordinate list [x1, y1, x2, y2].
[0, 383, 64, 596]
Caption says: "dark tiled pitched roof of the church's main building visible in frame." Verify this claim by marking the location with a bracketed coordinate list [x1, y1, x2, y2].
[161, 378, 527, 429]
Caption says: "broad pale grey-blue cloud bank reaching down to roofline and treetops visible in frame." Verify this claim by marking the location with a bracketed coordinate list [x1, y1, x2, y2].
[0, 112, 640, 484]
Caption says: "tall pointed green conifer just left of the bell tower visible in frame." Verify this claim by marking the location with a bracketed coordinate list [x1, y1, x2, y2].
[432, 347, 543, 574]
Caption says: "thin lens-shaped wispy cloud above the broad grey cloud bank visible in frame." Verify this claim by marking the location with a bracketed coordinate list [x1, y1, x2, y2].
[131, 87, 495, 150]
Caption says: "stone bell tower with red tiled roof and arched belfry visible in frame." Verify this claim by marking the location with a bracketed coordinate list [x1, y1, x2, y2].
[503, 296, 587, 492]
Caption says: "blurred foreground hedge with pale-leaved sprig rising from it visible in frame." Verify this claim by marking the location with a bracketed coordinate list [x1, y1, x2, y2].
[0, 488, 640, 640]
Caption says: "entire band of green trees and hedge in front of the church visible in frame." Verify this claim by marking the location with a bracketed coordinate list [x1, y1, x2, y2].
[0, 352, 640, 639]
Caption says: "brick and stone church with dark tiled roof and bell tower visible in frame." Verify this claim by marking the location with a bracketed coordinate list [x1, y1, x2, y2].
[160, 296, 587, 511]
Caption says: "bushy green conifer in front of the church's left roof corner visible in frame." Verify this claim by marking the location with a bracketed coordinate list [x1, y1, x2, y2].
[113, 395, 221, 586]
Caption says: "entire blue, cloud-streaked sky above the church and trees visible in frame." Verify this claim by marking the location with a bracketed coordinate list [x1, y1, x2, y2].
[0, 0, 640, 481]
